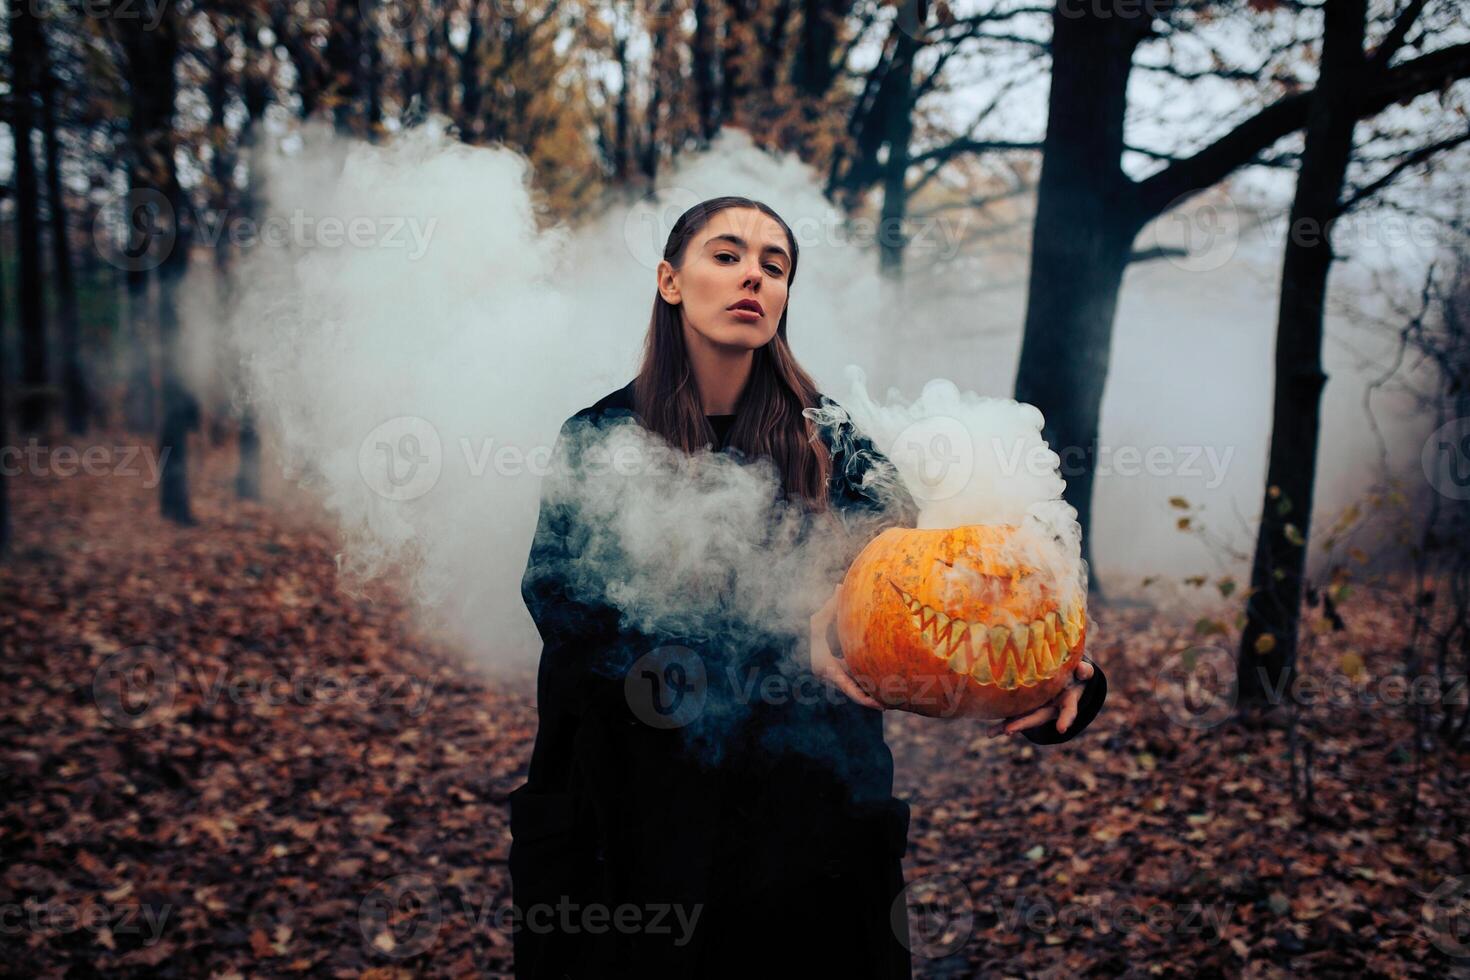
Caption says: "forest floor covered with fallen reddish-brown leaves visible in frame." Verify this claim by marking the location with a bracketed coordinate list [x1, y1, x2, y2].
[0, 435, 1470, 977]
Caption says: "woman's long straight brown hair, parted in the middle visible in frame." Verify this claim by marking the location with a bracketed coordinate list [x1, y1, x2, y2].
[634, 197, 832, 511]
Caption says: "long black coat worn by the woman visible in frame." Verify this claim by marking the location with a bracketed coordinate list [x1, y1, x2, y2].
[510, 383, 1105, 980]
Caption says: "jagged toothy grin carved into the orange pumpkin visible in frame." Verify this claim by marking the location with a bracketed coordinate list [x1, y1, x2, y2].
[889, 582, 1082, 691]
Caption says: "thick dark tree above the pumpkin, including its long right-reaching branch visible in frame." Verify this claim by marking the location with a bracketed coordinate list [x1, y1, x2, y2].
[1011, 0, 1470, 598]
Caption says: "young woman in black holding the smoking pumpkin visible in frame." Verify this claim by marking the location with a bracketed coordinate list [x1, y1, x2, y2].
[510, 197, 1105, 980]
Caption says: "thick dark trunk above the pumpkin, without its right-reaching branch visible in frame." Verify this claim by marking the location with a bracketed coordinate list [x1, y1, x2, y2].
[1014, 7, 1148, 597]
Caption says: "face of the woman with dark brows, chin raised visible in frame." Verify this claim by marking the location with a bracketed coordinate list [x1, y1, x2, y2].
[659, 207, 791, 350]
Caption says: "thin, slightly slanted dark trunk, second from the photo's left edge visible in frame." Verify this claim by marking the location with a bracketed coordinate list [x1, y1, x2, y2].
[35, 21, 91, 435]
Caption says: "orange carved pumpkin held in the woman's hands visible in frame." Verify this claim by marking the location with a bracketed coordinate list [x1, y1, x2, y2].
[836, 525, 1086, 718]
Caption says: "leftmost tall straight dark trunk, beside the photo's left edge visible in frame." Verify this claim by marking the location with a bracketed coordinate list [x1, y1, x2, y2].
[10, 0, 50, 432]
